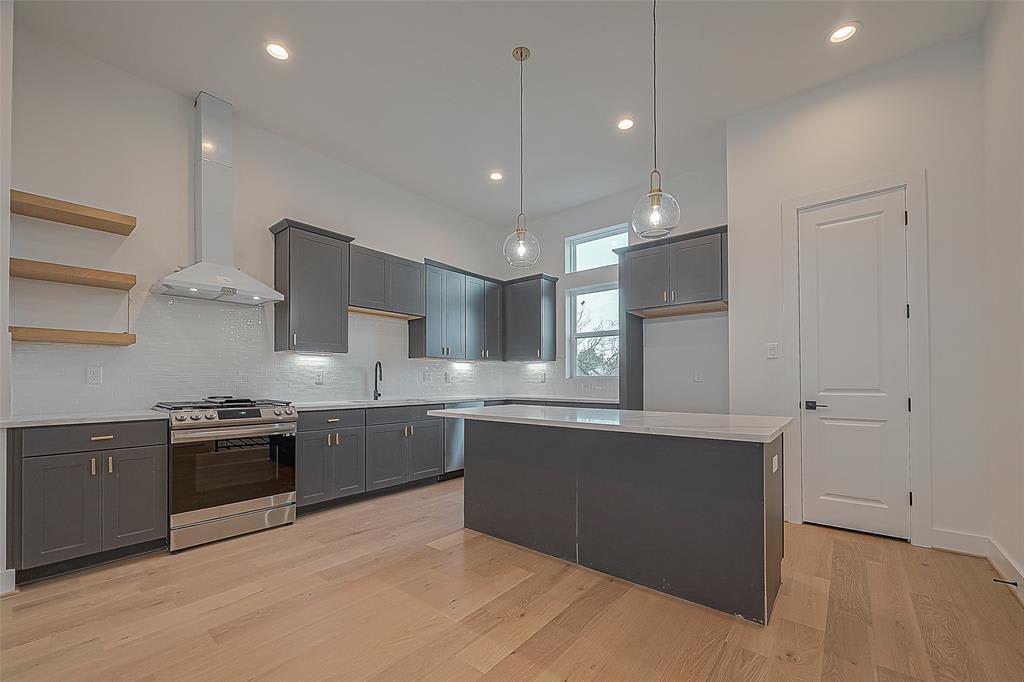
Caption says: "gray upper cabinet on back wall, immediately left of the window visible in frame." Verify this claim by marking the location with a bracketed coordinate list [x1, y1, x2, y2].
[504, 274, 556, 360]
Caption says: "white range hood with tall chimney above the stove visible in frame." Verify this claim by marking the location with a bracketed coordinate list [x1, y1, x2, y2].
[152, 92, 285, 305]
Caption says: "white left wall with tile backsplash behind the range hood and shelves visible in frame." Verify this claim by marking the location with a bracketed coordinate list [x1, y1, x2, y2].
[4, 30, 520, 415]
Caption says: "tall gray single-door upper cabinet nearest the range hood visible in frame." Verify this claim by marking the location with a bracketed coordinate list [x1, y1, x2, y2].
[270, 218, 352, 353]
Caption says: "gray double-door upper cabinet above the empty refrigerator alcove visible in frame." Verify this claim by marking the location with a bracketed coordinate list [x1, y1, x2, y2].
[620, 228, 728, 310]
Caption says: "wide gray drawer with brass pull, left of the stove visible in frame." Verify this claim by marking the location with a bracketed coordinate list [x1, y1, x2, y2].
[22, 419, 167, 457]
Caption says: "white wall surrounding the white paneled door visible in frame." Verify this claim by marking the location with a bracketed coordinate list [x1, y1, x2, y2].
[727, 34, 987, 543]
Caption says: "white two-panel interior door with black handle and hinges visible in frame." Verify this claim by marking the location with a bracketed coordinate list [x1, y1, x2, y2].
[798, 188, 910, 538]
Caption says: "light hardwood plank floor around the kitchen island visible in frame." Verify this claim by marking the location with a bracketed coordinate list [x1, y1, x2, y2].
[0, 479, 1024, 682]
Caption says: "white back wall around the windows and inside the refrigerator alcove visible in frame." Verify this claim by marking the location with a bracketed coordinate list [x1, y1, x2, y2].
[506, 159, 728, 405]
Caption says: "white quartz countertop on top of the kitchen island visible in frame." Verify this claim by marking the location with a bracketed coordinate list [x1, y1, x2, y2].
[427, 404, 793, 442]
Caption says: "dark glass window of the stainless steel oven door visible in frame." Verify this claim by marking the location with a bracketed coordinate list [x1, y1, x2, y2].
[171, 435, 295, 514]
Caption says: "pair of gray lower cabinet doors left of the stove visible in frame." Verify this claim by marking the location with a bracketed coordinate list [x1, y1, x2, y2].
[22, 445, 168, 568]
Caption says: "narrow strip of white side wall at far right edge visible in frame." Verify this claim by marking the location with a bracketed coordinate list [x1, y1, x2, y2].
[979, 3, 1024, 599]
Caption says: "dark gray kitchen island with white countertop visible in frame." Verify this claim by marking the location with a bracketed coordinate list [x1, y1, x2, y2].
[429, 406, 791, 624]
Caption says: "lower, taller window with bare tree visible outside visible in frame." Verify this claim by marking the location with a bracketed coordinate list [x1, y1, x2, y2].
[565, 285, 618, 377]
